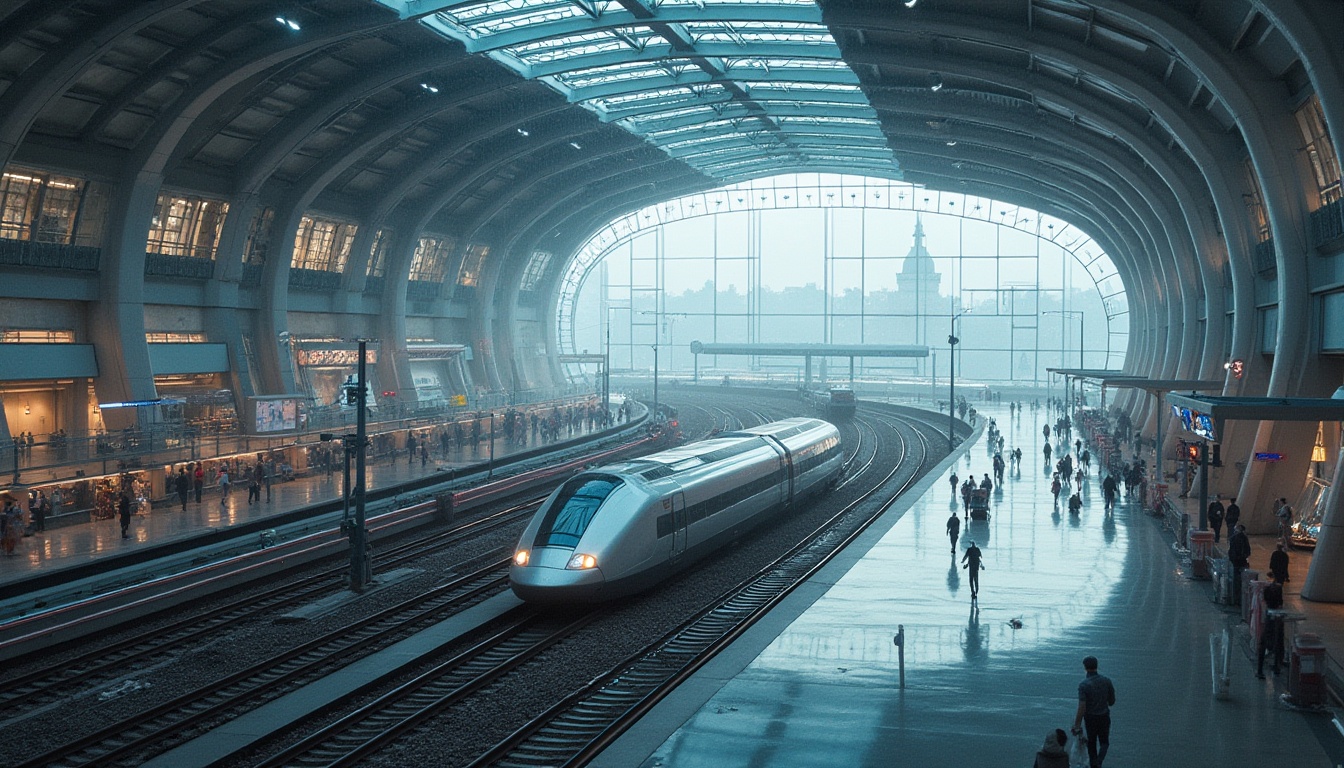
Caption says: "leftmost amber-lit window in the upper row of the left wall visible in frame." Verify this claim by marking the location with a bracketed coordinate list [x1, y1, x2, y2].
[0, 169, 85, 245]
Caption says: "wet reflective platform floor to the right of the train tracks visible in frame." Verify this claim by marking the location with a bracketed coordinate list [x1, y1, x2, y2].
[593, 408, 1344, 768]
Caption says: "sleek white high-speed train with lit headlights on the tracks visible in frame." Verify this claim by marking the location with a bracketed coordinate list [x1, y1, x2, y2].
[509, 418, 844, 603]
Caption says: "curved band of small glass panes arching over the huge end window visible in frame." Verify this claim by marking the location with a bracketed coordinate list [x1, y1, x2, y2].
[556, 174, 1129, 355]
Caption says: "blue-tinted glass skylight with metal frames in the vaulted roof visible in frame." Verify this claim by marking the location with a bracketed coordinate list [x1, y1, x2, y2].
[397, 0, 900, 180]
